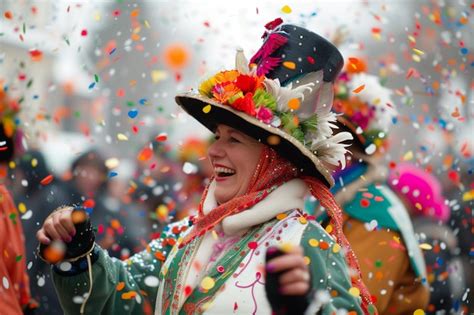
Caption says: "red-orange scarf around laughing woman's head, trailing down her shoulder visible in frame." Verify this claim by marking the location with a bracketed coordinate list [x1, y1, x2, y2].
[180, 146, 372, 314]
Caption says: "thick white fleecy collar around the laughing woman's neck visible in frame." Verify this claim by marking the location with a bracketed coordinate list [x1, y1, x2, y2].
[203, 178, 308, 235]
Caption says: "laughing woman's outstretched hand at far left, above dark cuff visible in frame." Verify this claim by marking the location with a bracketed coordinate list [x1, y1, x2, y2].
[36, 207, 76, 245]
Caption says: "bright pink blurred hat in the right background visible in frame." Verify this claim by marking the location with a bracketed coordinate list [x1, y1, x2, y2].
[389, 163, 451, 222]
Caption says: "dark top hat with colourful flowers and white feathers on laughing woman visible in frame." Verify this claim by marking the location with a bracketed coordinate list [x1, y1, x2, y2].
[176, 19, 352, 186]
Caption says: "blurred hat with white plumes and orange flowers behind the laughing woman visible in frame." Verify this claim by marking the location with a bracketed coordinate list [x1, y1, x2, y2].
[334, 58, 397, 155]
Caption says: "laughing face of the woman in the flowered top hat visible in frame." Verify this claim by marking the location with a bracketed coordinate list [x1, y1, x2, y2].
[208, 125, 264, 204]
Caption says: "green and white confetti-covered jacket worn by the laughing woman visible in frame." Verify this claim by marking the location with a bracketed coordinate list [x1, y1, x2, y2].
[53, 211, 362, 314]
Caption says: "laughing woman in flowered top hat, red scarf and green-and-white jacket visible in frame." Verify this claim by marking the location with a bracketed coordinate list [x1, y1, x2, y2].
[37, 19, 376, 314]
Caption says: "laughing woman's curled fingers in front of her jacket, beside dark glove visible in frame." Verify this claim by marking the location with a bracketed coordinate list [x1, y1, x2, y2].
[266, 246, 311, 296]
